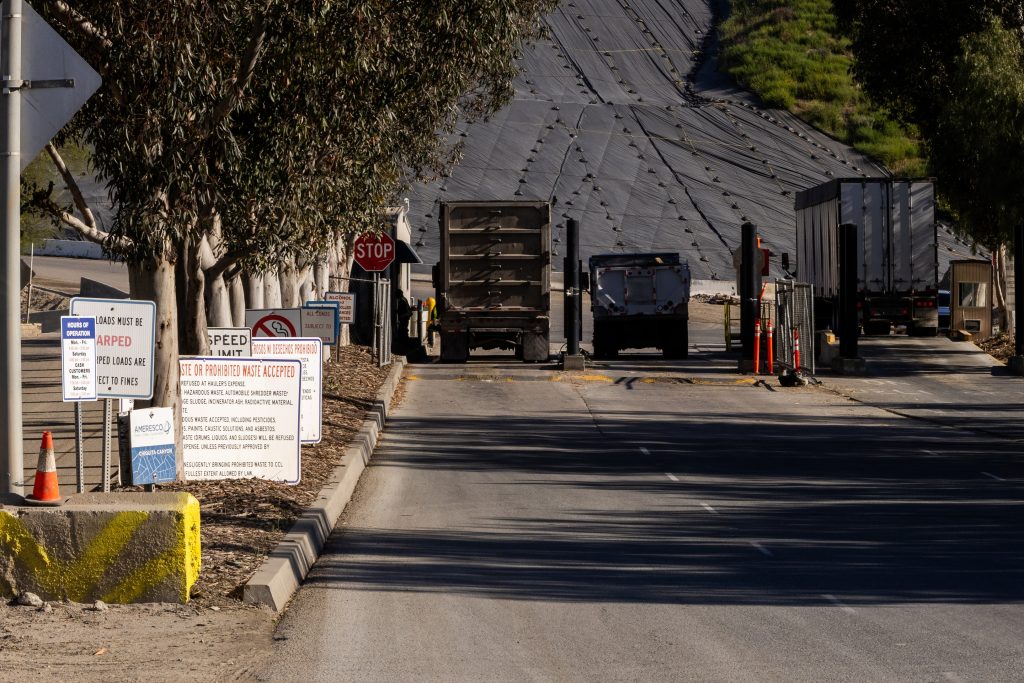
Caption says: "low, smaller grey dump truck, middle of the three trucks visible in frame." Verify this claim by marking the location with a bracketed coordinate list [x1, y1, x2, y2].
[589, 252, 690, 358]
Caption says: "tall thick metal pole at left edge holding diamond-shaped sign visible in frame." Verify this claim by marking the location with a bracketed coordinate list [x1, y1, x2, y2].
[0, 0, 25, 496]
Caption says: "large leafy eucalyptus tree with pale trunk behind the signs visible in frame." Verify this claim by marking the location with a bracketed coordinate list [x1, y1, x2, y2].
[32, 0, 555, 475]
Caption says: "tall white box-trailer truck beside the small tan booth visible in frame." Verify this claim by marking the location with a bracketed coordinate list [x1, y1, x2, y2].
[796, 178, 939, 336]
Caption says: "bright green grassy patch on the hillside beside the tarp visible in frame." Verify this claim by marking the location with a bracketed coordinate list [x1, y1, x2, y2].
[721, 0, 926, 176]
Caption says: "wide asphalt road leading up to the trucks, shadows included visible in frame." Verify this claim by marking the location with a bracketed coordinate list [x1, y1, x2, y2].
[263, 352, 1024, 681]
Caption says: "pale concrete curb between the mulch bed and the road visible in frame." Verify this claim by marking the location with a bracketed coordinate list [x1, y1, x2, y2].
[242, 360, 406, 612]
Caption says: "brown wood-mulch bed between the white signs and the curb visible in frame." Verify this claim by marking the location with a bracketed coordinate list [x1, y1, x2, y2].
[121, 346, 390, 604]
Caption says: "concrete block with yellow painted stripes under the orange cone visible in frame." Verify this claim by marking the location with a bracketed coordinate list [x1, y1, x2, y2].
[0, 493, 200, 603]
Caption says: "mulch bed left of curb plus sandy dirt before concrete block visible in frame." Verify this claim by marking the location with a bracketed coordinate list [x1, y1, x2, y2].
[0, 346, 400, 683]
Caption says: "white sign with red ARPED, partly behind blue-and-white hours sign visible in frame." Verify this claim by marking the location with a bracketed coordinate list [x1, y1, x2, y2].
[71, 297, 157, 398]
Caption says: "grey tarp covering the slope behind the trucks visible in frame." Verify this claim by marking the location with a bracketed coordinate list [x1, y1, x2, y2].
[411, 0, 968, 281]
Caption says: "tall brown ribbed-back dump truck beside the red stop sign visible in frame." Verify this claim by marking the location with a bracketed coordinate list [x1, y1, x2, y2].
[433, 202, 551, 362]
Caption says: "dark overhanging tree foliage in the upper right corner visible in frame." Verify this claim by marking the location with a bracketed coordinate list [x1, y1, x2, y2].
[834, 0, 1024, 248]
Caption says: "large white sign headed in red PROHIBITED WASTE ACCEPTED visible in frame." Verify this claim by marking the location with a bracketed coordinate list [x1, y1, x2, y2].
[180, 357, 302, 483]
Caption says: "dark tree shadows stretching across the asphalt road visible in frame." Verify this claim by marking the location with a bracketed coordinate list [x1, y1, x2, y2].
[308, 403, 1024, 605]
